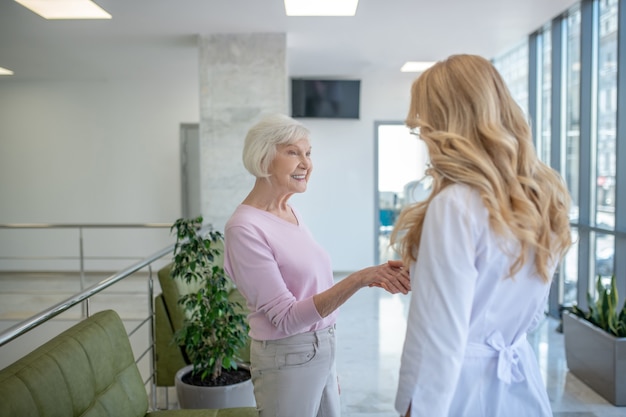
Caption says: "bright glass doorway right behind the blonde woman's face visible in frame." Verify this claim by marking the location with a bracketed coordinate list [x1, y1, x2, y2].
[374, 122, 428, 264]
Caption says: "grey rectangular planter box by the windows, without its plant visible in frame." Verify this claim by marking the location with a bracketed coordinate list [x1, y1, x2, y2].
[563, 311, 626, 406]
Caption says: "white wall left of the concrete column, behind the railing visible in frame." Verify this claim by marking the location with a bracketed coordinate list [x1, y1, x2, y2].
[0, 68, 198, 271]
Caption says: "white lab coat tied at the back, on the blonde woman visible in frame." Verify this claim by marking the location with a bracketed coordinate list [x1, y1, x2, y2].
[395, 184, 554, 417]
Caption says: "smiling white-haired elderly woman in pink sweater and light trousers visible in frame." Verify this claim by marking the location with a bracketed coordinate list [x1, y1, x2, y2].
[224, 115, 410, 417]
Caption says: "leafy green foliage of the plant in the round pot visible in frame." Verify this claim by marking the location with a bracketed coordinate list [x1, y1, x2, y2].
[170, 217, 248, 381]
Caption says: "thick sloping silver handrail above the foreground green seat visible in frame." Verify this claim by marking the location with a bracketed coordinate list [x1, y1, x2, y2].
[0, 244, 175, 346]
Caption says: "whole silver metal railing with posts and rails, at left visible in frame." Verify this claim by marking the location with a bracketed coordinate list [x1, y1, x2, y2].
[0, 224, 175, 409]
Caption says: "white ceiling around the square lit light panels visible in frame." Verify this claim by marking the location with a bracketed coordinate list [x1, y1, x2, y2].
[0, 0, 577, 82]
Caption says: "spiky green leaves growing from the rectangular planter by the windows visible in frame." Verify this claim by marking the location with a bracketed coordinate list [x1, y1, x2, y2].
[572, 275, 626, 337]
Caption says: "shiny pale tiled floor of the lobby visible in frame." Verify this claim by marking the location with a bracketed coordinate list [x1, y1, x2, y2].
[0, 273, 626, 417]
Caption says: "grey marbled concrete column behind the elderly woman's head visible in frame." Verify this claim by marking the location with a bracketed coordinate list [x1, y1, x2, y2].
[199, 33, 289, 231]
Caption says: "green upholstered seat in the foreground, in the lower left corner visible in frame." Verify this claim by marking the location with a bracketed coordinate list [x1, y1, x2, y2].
[0, 310, 258, 417]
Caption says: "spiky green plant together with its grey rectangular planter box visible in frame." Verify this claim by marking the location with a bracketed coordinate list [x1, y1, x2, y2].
[563, 275, 626, 406]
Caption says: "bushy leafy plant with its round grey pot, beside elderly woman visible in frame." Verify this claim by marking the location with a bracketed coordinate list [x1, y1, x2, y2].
[171, 217, 255, 408]
